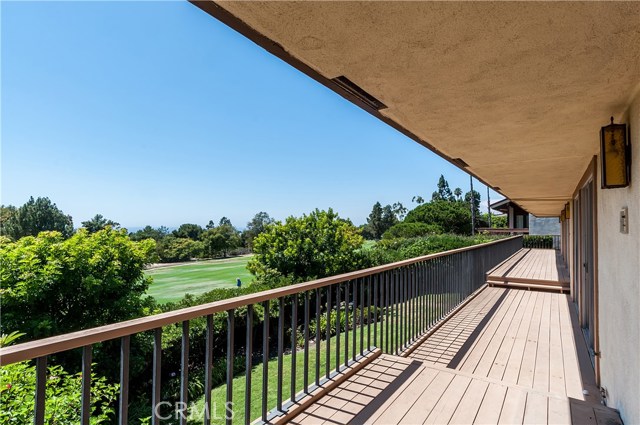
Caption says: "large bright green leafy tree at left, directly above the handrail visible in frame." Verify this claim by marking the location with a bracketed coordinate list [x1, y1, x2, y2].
[0, 228, 155, 339]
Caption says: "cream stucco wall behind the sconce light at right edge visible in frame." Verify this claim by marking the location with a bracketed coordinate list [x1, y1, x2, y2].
[597, 88, 640, 424]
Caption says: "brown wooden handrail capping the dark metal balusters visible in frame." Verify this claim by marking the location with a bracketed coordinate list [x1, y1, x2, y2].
[0, 236, 522, 366]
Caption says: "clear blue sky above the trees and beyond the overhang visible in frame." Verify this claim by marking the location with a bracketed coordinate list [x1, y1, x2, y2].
[1, 1, 498, 228]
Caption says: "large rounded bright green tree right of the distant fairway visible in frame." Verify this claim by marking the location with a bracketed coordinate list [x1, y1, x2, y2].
[247, 209, 364, 281]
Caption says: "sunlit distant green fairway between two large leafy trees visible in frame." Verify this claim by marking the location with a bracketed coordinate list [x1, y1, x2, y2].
[145, 256, 253, 303]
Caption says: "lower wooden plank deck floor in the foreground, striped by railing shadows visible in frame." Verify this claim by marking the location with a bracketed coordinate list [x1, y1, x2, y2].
[292, 288, 621, 425]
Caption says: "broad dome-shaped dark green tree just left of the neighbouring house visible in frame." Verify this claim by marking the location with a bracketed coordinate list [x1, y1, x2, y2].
[404, 200, 471, 235]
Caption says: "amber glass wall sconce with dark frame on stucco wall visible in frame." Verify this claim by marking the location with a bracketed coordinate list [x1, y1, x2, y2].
[600, 117, 631, 189]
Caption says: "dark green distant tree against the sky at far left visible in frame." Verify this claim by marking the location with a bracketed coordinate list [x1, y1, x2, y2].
[2, 196, 73, 240]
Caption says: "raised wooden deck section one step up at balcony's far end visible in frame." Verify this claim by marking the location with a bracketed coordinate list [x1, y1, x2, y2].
[487, 248, 569, 290]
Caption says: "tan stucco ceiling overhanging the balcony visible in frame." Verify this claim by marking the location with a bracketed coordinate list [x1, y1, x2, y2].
[196, 1, 640, 216]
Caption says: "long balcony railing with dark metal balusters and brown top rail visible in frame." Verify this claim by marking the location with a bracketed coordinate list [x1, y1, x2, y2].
[0, 236, 522, 425]
